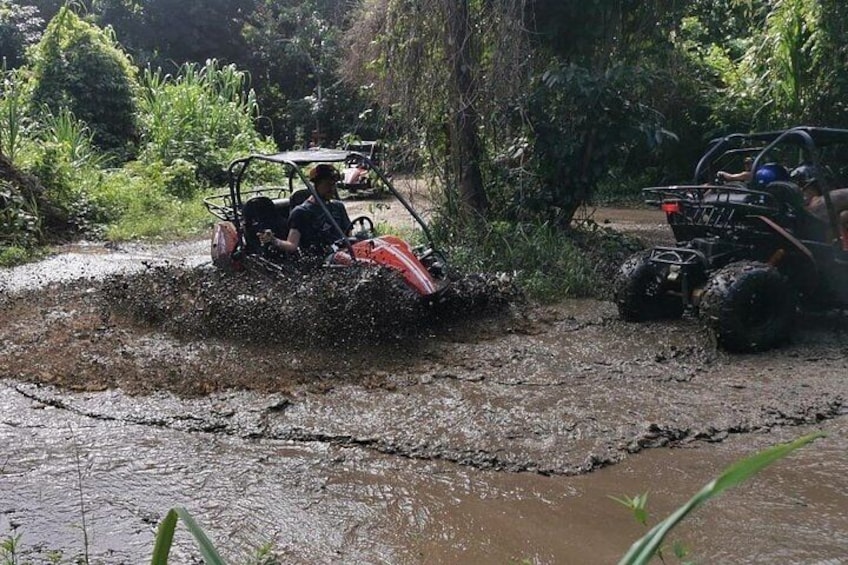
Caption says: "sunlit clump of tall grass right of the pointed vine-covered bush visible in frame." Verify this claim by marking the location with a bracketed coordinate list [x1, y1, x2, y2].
[140, 60, 274, 187]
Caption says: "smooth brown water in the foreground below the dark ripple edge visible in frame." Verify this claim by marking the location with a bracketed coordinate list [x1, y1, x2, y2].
[0, 383, 848, 564]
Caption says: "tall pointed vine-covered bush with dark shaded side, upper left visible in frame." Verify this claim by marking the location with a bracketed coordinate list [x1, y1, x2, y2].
[31, 7, 136, 157]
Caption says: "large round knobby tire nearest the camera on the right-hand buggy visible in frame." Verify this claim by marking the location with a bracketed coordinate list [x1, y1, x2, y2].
[699, 261, 797, 352]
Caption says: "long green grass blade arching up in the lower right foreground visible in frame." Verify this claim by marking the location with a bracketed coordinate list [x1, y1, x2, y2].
[618, 432, 825, 565]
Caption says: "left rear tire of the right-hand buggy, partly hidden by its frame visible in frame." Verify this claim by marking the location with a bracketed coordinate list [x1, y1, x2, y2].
[615, 251, 684, 322]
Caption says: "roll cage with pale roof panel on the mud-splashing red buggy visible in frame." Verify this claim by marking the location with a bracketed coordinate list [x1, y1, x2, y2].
[204, 148, 436, 262]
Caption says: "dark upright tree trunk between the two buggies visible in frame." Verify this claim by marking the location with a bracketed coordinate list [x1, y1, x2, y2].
[443, 0, 488, 216]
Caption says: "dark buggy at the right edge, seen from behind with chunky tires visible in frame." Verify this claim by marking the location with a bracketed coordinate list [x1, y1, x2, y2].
[615, 127, 848, 351]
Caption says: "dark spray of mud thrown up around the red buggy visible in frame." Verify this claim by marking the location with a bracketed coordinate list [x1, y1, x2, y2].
[102, 263, 521, 350]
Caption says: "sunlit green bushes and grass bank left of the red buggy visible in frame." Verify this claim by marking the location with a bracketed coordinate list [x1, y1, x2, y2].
[0, 8, 275, 266]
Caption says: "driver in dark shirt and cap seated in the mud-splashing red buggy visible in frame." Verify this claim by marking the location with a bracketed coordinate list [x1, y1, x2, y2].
[256, 163, 352, 253]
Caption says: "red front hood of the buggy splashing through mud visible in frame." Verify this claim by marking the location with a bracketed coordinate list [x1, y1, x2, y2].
[329, 235, 446, 297]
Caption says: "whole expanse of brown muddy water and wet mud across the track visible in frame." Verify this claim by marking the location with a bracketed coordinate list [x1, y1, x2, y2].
[0, 211, 848, 564]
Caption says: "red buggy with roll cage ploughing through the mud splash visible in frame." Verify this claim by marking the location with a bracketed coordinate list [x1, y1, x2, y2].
[204, 148, 448, 299]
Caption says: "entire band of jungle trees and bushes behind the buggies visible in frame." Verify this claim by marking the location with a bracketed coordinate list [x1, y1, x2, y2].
[0, 0, 848, 294]
